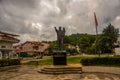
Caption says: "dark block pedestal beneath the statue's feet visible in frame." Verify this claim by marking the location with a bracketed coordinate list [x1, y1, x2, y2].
[53, 50, 67, 65]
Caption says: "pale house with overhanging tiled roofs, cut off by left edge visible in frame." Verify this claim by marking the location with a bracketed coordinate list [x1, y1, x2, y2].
[0, 32, 20, 59]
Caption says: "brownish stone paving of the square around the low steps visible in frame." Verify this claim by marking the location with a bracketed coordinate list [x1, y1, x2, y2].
[0, 66, 120, 80]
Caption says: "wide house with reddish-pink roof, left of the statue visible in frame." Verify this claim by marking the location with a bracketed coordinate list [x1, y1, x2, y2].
[15, 41, 49, 55]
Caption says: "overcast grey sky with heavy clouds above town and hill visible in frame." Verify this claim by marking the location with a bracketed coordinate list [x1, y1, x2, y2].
[0, 0, 120, 42]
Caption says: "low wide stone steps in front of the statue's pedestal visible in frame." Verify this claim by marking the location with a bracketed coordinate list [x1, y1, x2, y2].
[38, 66, 82, 74]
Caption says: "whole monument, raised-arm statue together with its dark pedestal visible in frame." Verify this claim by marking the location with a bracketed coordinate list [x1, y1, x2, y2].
[53, 27, 67, 65]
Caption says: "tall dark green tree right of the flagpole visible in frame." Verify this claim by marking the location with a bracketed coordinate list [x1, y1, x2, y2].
[98, 24, 119, 53]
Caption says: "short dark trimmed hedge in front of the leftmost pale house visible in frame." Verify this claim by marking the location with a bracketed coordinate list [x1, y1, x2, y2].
[0, 59, 20, 67]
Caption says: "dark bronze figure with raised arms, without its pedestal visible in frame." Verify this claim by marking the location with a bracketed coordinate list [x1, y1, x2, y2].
[55, 27, 65, 50]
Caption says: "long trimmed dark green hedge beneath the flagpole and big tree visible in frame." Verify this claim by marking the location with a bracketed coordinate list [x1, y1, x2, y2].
[80, 57, 120, 66]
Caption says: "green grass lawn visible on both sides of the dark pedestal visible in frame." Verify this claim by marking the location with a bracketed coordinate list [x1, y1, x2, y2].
[39, 56, 82, 65]
